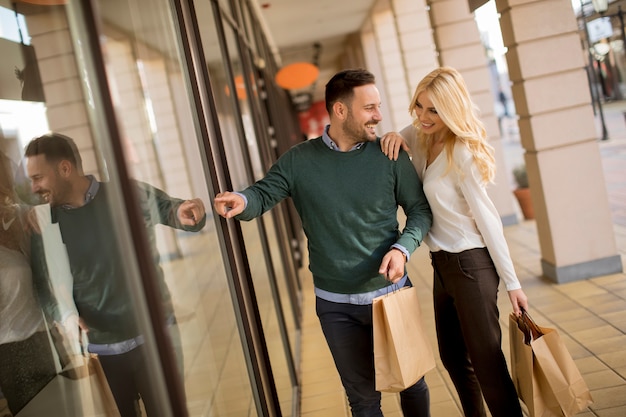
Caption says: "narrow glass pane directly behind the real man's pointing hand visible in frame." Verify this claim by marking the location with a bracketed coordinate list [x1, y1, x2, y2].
[191, 2, 297, 415]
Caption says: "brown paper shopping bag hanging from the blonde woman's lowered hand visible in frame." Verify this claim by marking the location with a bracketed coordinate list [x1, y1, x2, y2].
[509, 312, 593, 417]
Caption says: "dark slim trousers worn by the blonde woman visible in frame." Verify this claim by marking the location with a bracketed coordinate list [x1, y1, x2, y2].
[431, 248, 522, 417]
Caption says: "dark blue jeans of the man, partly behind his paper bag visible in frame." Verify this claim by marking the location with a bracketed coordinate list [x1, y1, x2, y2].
[315, 297, 430, 417]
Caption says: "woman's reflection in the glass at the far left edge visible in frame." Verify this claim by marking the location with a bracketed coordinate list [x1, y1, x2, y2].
[0, 152, 56, 414]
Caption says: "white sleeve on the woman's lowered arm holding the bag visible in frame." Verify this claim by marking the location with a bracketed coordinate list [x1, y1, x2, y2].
[459, 156, 522, 291]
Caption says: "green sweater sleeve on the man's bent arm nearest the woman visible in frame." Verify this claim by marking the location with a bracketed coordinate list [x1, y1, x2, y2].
[395, 152, 433, 253]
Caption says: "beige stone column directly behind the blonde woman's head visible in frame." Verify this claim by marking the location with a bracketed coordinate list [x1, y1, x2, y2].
[430, 0, 517, 226]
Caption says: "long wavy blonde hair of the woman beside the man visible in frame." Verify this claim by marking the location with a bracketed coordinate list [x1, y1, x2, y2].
[409, 67, 495, 183]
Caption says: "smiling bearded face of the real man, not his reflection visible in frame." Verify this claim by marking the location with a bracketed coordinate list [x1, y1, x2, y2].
[343, 84, 383, 142]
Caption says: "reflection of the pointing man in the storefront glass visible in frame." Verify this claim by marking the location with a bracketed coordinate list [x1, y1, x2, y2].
[25, 133, 206, 417]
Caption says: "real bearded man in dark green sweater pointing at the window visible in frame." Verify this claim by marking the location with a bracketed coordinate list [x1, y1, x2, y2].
[214, 70, 432, 417]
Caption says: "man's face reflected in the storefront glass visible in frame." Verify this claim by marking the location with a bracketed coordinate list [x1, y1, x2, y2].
[26, 155, 71, 207]
